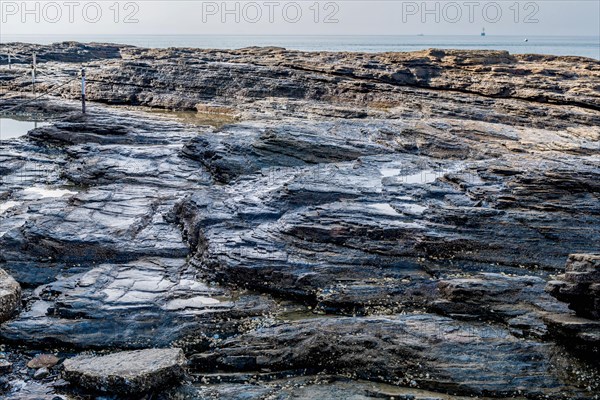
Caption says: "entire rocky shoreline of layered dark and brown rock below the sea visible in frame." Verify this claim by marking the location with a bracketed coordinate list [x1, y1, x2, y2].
[0, 43, 600, 399]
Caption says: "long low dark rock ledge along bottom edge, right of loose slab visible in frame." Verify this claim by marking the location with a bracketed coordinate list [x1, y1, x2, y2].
[192, 314, 596, 398]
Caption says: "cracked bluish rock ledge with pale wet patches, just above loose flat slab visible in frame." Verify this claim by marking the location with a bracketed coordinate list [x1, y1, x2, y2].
[2, 258, 272, 348]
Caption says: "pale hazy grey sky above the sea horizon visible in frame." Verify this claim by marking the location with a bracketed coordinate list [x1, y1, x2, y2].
[0, 0, 600, 36]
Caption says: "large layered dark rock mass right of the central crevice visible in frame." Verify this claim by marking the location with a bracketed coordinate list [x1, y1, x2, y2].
[178, 139, 600, 306]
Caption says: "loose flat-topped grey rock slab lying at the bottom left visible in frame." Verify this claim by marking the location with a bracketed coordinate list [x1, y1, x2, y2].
[64, 349, 186, 395]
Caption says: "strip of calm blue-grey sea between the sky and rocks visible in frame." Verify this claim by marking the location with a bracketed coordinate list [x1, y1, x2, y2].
[0, 34, 600, 60]
